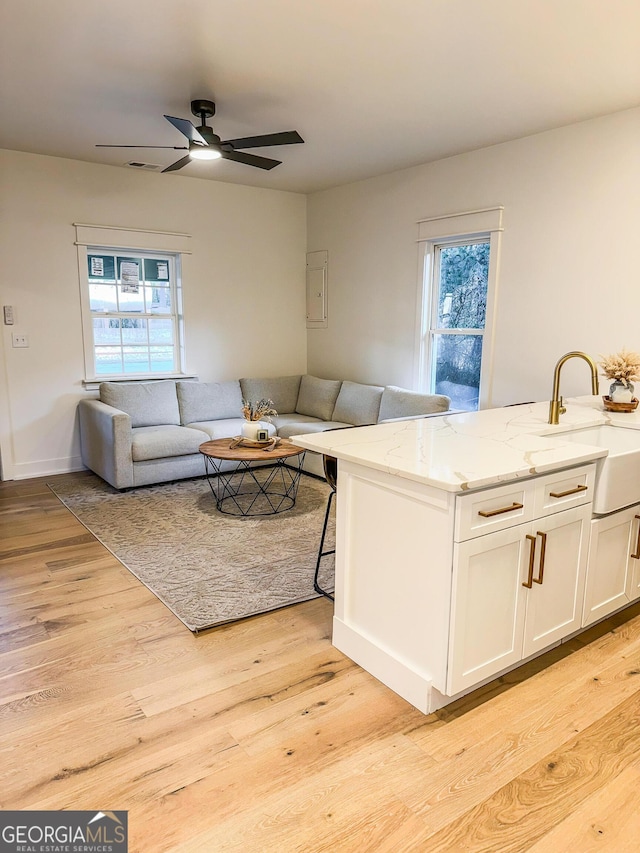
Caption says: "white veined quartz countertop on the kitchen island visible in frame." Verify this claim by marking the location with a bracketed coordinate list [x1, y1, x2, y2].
[292, 396, 640, 492]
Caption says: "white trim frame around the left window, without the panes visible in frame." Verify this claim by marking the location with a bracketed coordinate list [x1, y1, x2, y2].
[74, 223, 190, 389]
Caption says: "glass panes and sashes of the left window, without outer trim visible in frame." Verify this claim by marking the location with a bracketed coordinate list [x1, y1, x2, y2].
[87, 247, 180, 377]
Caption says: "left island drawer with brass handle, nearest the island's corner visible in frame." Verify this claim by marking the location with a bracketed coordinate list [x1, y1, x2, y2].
[454, 480, 535, 542]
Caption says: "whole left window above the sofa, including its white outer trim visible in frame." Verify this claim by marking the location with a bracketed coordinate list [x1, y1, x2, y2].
[76, 225, 188, 383]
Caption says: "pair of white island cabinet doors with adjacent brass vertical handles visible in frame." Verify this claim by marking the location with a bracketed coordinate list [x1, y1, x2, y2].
[447, 505, 591, 696]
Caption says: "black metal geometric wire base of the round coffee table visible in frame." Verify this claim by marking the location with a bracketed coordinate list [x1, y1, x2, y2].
[204, 453, 305, 516]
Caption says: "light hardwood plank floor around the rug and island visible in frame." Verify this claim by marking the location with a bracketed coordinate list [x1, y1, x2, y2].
[0, 478, 640, 853]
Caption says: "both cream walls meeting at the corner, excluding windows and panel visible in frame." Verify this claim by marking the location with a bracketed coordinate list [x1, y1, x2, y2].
[0, 109, 640, 479]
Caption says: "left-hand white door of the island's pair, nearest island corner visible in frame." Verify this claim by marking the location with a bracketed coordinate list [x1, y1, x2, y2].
[447, 524, 533, 696]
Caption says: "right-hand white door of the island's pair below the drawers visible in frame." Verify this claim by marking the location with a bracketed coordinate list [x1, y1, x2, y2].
[522, 505, 591, 658]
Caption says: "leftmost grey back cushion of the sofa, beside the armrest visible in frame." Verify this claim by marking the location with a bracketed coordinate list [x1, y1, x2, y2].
[100, 379, 180, 427]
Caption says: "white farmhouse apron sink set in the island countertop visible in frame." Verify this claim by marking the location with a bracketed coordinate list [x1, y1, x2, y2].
[556, 424, 640, 515]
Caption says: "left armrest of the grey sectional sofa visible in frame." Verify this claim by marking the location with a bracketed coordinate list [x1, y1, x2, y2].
[78, 400, 133, 489]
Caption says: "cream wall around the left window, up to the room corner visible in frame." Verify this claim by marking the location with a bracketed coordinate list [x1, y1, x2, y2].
[0, 151, 306, 479]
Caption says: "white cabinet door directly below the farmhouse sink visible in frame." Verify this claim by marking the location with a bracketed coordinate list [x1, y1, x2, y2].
[582, 507, 640, 627]
